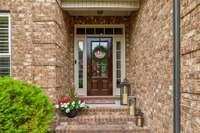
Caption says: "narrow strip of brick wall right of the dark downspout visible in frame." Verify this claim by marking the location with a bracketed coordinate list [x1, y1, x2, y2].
[181, 0, 200, 133]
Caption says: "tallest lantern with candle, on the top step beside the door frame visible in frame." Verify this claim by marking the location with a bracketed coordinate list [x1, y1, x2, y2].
[120, 79, 130, 105]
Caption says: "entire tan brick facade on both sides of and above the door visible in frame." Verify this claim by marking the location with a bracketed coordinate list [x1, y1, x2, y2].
[0, 0, 200, 133]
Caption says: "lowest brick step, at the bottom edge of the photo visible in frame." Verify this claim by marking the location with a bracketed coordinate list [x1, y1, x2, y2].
[55, 123, 149, 133]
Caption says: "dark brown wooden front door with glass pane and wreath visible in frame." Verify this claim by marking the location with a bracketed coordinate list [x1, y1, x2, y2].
[87, 37, 113, 96]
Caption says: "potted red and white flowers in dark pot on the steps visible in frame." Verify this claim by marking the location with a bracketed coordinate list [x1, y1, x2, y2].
[56, 89, 89, 118]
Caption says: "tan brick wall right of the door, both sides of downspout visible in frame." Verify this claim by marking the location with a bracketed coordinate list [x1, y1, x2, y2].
[128, 0, 200, 133]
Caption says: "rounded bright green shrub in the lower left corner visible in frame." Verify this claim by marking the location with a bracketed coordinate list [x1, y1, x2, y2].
[0, 77, 54, 133]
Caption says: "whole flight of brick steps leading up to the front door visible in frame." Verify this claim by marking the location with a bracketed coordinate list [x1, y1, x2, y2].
[55, 106, 149, 133]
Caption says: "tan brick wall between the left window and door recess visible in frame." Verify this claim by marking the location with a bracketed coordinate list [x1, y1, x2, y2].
[0, 0, 73, 100]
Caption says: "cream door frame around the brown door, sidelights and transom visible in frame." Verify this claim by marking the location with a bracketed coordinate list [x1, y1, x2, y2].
[74, 24, 126, 96]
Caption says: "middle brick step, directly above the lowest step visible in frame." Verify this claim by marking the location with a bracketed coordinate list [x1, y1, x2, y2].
[60, 115, 135, 125]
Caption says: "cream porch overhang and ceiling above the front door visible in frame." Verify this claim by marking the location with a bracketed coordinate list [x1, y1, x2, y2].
[62, 0, 139, 16]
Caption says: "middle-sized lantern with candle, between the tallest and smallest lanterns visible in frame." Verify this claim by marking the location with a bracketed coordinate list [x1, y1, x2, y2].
[128, 96, 136, 115]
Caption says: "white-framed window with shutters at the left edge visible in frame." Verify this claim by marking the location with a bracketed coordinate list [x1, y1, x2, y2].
[0, 13, 10, 77]
